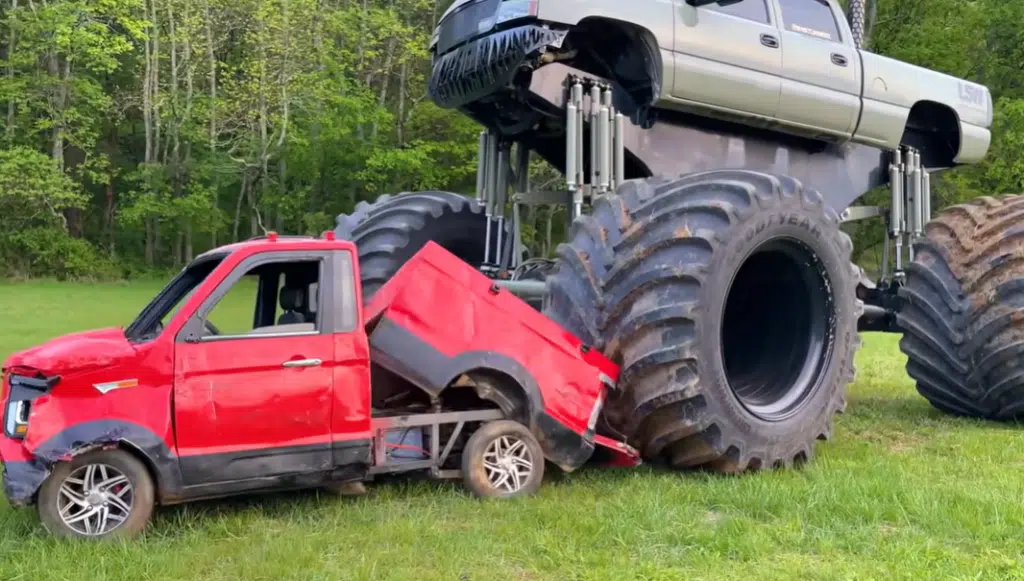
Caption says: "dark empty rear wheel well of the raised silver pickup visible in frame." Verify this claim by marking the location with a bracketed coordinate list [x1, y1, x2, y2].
[900, 100, 961, 168]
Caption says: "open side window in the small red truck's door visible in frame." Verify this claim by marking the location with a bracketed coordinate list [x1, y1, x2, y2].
[205, 259, 321, 336]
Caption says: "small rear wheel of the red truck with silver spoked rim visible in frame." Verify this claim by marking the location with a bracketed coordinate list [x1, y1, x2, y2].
[462, 420, 545, 498]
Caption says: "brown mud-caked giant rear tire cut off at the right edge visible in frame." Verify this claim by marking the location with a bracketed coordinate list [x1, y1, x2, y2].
[896, 195, 1024, 420]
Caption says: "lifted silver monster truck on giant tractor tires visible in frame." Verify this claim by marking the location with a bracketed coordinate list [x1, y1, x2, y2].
[337, 0, 1007, 472]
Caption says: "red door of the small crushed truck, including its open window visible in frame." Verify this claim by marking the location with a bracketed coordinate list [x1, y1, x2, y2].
[174, 251, 337, 486]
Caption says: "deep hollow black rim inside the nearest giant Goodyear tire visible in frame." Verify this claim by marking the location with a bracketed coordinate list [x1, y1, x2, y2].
[719, 237, 836, 421]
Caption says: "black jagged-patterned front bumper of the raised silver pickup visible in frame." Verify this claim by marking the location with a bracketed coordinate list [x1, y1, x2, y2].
[427, 24, 567, 109]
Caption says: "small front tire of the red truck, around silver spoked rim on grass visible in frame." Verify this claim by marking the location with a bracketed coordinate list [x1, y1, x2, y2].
[37, 449, 156, 540]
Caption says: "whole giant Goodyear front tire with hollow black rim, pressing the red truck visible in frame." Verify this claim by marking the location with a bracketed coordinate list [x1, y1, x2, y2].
[546, 170, 862, 472]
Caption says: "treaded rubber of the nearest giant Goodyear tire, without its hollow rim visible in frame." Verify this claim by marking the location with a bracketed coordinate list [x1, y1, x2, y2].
[547, 170, 858, 472]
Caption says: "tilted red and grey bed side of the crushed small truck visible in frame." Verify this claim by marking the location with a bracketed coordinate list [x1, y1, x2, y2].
[366, 243, 617, 470]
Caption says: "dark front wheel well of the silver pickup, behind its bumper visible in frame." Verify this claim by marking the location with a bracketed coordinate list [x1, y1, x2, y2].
[565, 16, 662, 116]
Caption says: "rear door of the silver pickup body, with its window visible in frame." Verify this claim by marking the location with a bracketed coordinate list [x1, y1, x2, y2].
[773, 0, 861, 137]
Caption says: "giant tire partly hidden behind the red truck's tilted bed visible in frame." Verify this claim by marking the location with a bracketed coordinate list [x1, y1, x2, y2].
[335, 192, 510, 302]
